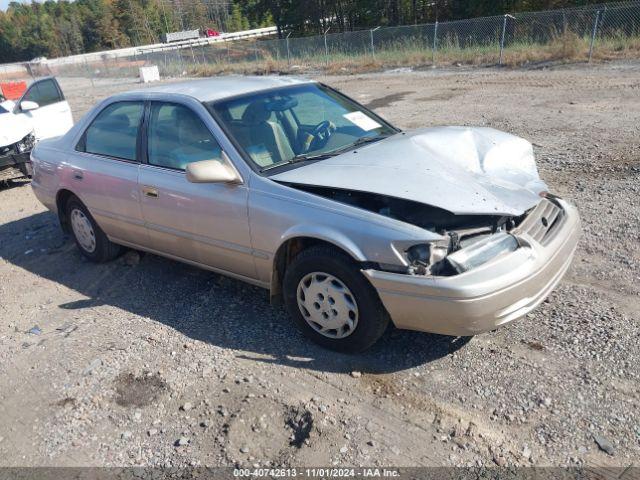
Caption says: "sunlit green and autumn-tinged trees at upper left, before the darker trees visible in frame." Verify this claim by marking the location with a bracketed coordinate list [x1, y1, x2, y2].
[0, 0, 255, 63]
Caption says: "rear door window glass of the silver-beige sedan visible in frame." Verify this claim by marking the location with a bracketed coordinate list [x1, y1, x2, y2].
[77, 102, 144, 161]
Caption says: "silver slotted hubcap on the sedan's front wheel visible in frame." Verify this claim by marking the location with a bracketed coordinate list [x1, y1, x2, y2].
[297, 272, 358, 338]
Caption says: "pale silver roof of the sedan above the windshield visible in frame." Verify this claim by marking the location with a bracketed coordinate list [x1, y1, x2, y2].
[130, 75, 315, 102]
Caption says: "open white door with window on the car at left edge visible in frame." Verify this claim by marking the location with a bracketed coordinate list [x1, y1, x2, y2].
[15, 77, 73, 140]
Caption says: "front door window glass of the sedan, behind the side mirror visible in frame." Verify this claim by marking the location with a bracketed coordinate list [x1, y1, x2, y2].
[148, 103, 222, 170]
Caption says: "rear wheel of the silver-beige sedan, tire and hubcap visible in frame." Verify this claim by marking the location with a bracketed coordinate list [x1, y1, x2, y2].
[65, 196, 122, 263]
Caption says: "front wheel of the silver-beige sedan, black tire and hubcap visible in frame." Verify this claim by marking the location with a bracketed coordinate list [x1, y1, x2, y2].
[283, 246, 389, 353]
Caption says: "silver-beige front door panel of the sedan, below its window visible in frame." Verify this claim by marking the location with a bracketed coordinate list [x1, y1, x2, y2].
[138, 165, 256, 278]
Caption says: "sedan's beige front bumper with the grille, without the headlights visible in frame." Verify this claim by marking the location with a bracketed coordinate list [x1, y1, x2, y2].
[363, 199, 580, 336]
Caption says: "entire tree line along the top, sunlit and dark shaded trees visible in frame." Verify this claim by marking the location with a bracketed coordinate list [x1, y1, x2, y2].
[0, 0, 624, 62]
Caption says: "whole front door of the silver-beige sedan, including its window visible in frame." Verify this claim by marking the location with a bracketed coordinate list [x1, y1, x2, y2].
[138, 102, 256, 278]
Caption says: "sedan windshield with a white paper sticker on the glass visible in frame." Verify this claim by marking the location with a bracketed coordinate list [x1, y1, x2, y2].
[209, 84, 396, 170]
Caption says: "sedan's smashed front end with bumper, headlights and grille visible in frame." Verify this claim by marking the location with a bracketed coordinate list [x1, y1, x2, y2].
[363, 195, 580, 335]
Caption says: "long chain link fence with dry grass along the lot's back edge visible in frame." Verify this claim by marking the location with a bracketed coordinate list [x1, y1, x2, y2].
[0, 0, 640, 95]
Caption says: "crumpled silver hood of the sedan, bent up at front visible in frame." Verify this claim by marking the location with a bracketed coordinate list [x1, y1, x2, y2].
[271, 127, 547, 216]
